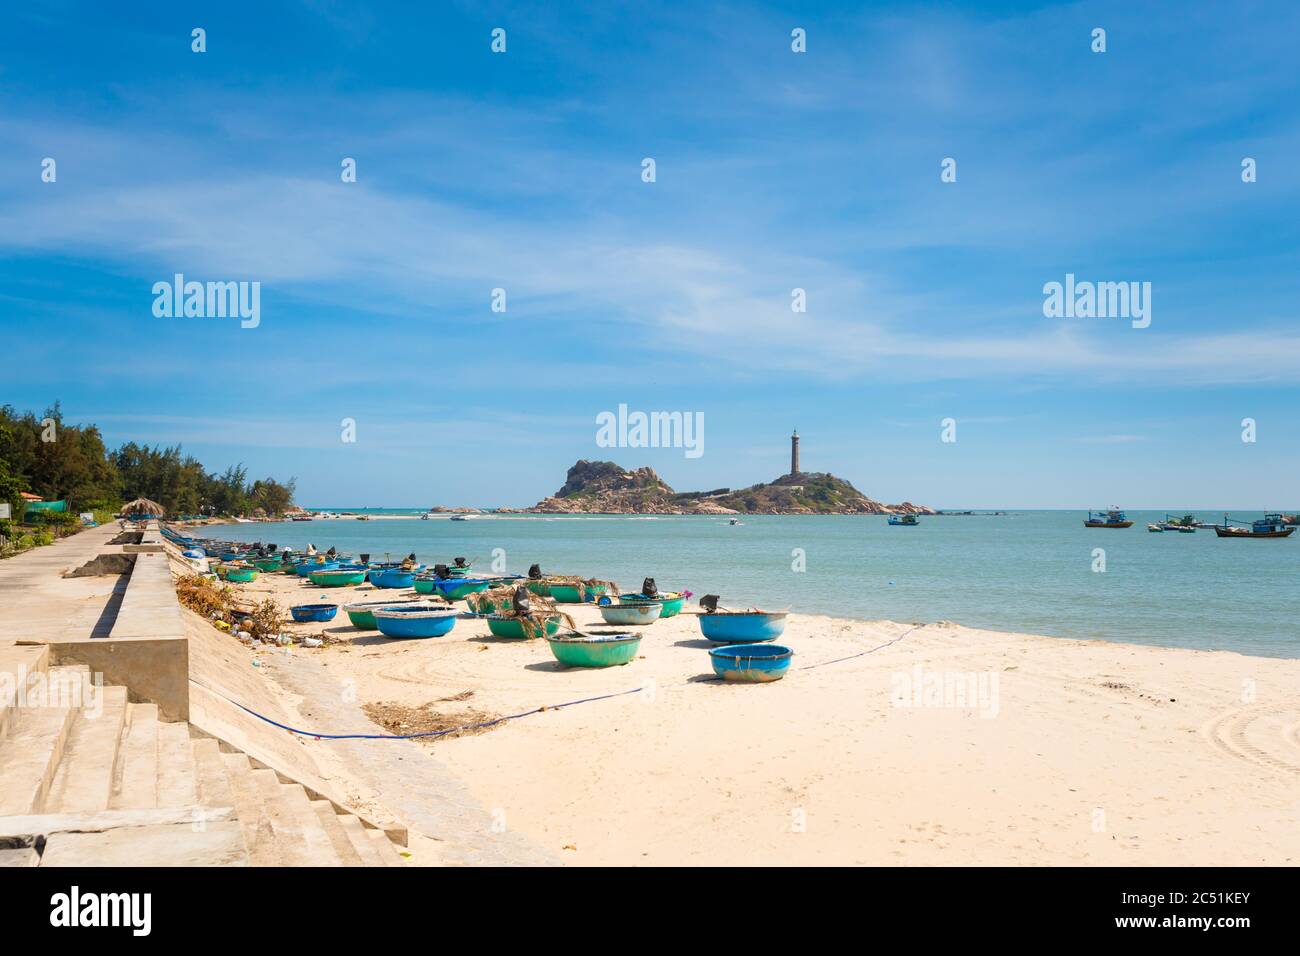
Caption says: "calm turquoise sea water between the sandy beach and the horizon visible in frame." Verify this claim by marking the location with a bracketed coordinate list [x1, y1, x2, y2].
[208, 509, 1300, 658]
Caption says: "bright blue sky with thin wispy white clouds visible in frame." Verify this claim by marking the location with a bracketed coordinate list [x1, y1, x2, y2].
[0, 0, 1300, 509]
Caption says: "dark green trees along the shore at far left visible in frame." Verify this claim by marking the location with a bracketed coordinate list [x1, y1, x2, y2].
[0, 402, 294, 518]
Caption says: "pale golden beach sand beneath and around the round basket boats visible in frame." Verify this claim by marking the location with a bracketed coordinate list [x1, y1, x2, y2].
[215, 575, 1300, 865]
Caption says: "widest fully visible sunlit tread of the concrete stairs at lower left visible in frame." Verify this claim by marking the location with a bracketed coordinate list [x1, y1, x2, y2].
[44, 687, 126, 813]
